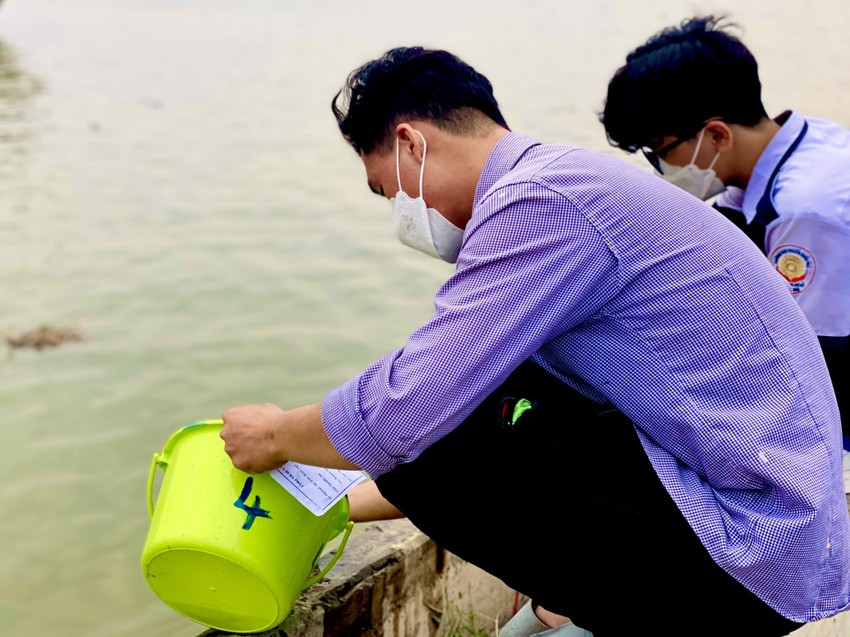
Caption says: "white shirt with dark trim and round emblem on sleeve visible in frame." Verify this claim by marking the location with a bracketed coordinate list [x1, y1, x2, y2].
[716, 112, 850, 337]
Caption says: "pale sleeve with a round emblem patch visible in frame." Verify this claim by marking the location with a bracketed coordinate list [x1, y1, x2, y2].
[765, 213, 850, 336]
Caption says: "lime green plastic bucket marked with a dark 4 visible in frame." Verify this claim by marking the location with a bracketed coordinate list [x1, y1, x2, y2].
[142, 420, 353, 633]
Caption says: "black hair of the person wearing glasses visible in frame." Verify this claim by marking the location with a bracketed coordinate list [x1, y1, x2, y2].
[599, 15, 767, 153]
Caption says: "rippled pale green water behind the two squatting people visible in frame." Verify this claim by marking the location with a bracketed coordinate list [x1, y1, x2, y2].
[0, 0, 850, 637]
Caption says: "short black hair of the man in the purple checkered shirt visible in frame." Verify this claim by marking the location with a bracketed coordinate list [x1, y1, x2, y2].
[331, 46, 508, 154]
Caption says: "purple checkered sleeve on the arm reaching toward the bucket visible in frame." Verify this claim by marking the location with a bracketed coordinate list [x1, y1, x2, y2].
[322, 183, 618, 477]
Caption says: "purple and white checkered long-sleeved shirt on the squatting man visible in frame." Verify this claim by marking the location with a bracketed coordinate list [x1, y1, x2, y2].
[322, 133, 850, 622]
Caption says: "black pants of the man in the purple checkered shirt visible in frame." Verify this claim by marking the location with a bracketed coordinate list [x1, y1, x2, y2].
[376, 362, 800, 637]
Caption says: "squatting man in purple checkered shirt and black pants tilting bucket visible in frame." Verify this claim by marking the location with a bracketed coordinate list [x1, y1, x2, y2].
[222, 47, 850, 637]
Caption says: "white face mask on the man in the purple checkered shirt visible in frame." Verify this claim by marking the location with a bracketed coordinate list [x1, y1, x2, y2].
[390, 131, 463, 263]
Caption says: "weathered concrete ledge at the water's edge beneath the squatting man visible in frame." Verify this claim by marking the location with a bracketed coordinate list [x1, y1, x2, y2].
[199, 520, 850, 637]
